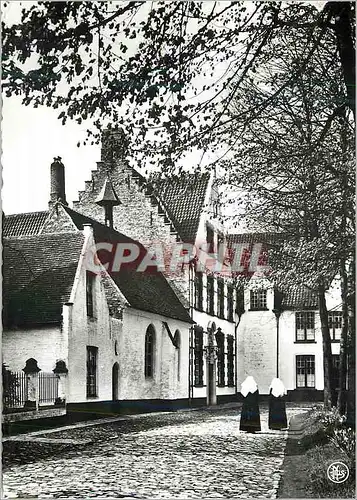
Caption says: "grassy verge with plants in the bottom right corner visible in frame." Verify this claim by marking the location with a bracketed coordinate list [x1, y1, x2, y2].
[278, 406, 355, 499]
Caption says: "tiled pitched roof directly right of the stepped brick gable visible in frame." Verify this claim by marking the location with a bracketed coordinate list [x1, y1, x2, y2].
[155, 173, 210, 243]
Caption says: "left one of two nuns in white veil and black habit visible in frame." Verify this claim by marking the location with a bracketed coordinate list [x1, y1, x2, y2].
[239, 377, 261, 432]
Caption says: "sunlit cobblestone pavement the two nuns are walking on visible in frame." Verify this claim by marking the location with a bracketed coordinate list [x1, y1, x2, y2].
[3, 408, 303, 499]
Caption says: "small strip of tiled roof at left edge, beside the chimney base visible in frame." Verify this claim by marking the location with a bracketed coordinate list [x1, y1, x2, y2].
[2, 211, 49, 237]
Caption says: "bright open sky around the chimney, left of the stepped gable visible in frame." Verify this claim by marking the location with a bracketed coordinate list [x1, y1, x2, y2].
[1, 0, 325, 215]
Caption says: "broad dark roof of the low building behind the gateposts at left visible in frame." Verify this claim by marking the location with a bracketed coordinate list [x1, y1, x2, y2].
[3, 233, 84, 327]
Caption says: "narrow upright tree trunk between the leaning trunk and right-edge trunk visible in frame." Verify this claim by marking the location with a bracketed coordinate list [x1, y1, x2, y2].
[337, 260, 349, 415]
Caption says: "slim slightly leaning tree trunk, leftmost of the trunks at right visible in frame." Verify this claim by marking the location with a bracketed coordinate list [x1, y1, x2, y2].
[318, 284, 332, 409]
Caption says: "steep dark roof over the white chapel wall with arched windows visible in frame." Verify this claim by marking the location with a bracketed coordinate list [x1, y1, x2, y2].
[63, 205, 192, 323]
